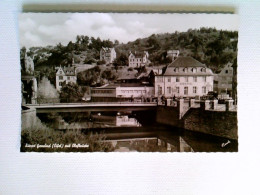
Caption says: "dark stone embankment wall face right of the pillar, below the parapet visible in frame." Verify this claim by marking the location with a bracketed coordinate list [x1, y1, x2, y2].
[182, 108, 238, 139]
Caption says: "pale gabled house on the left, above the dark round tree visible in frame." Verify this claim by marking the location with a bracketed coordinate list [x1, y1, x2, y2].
[56, 66, 77, 91]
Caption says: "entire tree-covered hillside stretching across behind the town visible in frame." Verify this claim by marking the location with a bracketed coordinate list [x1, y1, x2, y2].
[21, 28, 238, 75]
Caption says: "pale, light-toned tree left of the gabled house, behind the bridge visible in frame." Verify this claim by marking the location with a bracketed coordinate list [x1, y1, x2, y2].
[37, 77, 59, 103]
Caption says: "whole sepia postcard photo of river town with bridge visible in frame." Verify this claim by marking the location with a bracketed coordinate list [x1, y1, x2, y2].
[19, 13, 238, 152]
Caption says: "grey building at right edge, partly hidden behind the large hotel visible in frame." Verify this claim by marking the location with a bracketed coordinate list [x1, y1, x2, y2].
[216, 63, 233, 95]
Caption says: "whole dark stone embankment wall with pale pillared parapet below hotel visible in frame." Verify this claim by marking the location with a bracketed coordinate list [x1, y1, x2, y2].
[156, 100, 238, 139]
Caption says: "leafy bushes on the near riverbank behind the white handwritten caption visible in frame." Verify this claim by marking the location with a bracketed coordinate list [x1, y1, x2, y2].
[20, 118, 114, 152]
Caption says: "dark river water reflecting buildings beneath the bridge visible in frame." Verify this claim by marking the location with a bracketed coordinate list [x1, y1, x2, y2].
[37, 109, 238, 152]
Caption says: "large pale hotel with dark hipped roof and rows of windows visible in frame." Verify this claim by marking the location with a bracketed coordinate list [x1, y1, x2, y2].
[154, 57, 213, 97]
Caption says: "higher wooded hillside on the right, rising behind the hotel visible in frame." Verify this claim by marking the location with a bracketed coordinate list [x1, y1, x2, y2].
[116, 28, 238, 72]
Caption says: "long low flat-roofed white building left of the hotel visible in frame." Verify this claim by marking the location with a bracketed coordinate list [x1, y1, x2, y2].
[91, 83, 154, 102]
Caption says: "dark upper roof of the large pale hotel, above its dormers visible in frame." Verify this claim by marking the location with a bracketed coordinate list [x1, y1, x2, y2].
[168, 56, 206, 67]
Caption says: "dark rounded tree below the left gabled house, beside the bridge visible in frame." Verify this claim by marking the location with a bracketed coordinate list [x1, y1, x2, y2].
[60, 83, 84, 102]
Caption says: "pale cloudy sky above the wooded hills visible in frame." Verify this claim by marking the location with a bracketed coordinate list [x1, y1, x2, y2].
[19, 13, 239, 48]
